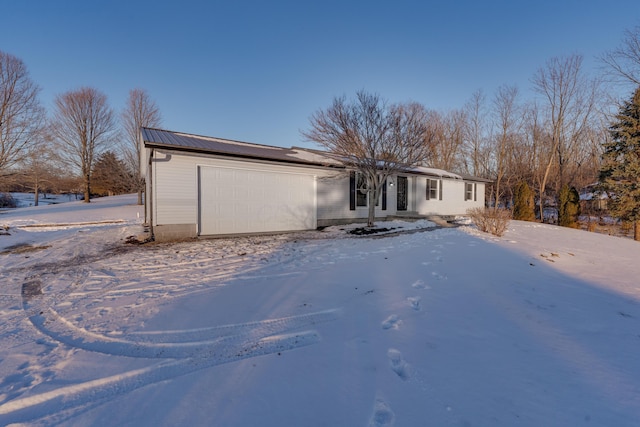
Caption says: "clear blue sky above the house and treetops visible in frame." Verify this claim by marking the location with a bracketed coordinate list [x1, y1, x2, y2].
[0, 0, 640, 147]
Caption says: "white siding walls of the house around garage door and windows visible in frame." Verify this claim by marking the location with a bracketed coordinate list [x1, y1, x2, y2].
[147, 145, 485, 237]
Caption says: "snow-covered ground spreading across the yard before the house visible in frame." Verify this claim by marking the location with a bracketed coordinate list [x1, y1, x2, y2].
[0, 196, 640, 426]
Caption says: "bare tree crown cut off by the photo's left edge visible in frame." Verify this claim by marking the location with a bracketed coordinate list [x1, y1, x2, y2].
[0, 51, 44, 176]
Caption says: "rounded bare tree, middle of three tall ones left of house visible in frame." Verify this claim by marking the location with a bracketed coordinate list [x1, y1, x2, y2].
[50, 87, 116, 203]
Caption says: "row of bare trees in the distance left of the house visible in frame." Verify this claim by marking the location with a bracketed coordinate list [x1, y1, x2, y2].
[0, 51, 161, 205]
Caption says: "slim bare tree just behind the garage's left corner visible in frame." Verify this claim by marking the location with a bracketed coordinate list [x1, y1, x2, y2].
[122, 89, 162, 205]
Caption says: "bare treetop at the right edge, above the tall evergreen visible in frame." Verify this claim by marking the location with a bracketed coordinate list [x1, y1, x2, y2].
[600, 26, 640, 87]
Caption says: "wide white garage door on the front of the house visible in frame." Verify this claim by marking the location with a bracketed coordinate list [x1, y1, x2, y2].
[200, 166, 316, 235]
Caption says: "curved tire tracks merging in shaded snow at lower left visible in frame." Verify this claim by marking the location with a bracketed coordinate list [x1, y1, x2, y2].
[0, 280, 339, 425]
